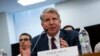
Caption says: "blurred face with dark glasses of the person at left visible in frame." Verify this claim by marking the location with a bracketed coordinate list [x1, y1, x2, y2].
[19, 35, 31, 49]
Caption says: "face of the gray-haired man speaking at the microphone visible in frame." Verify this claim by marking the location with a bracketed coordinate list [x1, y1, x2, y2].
[41, 13, 61, 36]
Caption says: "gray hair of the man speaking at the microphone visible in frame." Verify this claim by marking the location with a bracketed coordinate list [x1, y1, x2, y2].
[40, 8, 60, 21]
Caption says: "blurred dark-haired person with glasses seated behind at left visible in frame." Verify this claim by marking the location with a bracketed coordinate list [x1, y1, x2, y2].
[18, 33, 32, 56]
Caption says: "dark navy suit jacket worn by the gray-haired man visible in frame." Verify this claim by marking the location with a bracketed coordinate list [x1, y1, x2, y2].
[31, 30, 81, 56]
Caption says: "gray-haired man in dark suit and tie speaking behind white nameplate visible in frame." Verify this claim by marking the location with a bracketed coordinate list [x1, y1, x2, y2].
[31, 8, 80, 56]
